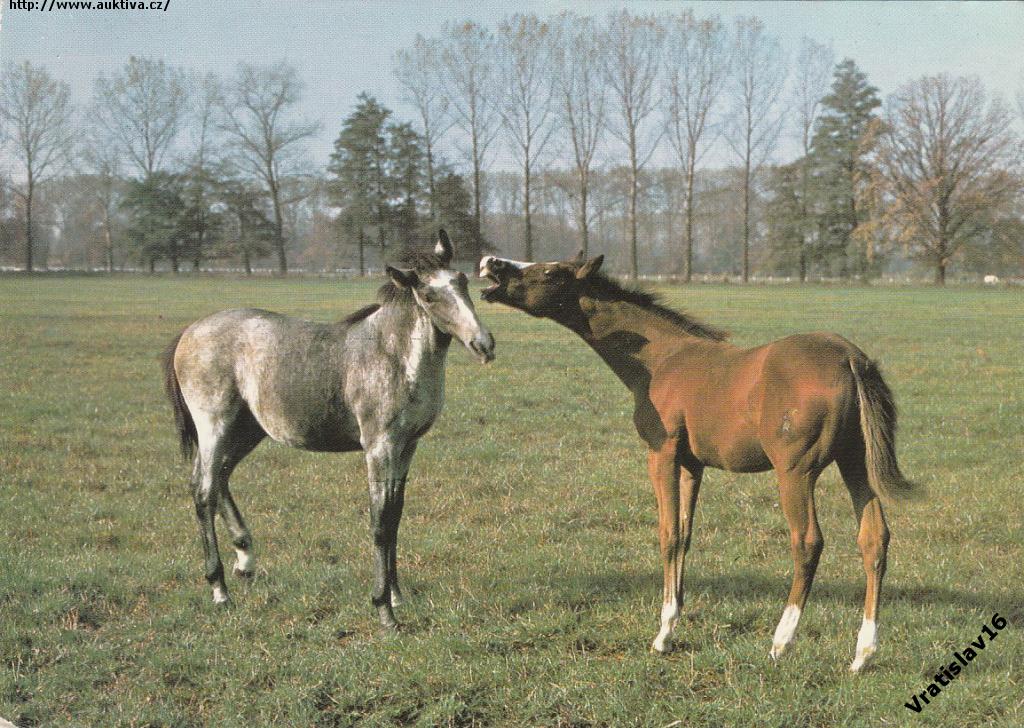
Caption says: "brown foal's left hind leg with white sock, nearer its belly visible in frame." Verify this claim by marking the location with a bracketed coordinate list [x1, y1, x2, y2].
[771, 471, 824, 659]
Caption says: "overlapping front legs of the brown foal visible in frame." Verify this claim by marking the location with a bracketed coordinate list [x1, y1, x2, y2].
[647, 438, 702, 652]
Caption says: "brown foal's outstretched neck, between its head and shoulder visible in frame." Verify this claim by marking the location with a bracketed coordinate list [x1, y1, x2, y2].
[555, 295, 696, 391]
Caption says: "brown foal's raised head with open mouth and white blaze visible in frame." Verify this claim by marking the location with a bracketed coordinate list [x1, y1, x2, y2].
[480, 255, 604, 316]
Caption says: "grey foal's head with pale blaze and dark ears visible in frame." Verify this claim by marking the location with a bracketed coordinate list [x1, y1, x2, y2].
[385, 229, 495, 363]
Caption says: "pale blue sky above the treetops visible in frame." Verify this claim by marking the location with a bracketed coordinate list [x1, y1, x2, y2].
[0, 0, 1024, 166]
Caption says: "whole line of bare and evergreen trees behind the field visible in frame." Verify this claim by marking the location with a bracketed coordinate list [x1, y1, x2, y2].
[0, 10, 1024, 283]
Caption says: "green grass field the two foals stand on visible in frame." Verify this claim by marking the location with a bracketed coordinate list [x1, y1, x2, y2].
[0, 277, 1024, 728]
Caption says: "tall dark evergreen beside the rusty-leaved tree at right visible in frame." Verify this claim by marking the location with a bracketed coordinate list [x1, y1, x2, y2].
[811, 58, 881, 279]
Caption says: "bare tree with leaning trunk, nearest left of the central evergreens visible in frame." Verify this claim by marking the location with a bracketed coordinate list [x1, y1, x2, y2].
[221, 61, 319, 275]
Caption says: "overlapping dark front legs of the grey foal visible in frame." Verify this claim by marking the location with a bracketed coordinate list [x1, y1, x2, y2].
[367, 438, 412, 629]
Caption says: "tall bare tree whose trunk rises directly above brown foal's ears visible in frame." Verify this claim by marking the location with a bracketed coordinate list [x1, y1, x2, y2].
[552, 12, 607, 257]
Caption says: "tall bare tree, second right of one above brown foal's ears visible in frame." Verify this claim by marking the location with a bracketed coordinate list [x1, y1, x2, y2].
[665, 10, 729, 283]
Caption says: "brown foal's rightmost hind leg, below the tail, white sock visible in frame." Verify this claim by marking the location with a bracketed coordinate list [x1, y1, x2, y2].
[839, 451, 889, 673]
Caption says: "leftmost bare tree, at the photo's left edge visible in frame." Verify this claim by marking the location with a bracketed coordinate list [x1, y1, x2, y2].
[0, 60, 74, 270]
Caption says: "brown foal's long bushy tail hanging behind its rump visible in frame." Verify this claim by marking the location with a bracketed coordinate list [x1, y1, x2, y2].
[850, 355, 919, 500]
